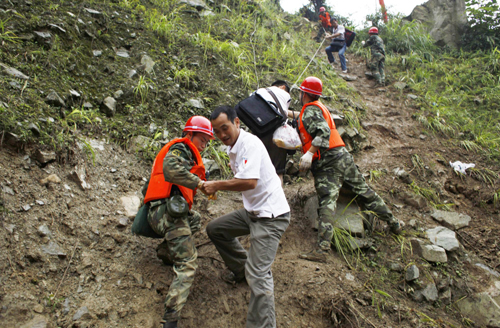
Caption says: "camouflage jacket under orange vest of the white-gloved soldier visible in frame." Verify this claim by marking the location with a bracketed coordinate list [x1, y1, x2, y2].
[302, 106, 344, 173]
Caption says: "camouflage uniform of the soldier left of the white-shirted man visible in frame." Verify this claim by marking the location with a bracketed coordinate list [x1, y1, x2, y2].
[148, 143, 200, 321]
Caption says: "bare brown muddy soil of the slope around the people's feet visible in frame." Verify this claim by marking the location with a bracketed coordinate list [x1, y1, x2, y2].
[0, 53, 500, 328]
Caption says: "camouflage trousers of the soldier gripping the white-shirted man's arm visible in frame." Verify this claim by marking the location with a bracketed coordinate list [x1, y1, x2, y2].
[148, 201, 200, 321]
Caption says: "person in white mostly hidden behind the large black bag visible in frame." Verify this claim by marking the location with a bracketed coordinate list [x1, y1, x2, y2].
[255, 80, 292, 180]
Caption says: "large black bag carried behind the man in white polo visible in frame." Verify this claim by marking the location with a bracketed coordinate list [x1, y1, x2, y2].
[235, 88, 287, 138]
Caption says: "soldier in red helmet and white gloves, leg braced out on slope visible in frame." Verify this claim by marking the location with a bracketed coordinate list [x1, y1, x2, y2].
[288, 76, 400, 262]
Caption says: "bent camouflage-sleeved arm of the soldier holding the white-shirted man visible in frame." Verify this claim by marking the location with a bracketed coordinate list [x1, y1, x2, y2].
[163, 144, 200, 190]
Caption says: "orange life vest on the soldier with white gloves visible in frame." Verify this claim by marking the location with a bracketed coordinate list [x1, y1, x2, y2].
[299, 100, 345, 161]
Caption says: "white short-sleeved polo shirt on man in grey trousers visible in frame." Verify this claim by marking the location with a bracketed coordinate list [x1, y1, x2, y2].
[227, 129, 290, 218]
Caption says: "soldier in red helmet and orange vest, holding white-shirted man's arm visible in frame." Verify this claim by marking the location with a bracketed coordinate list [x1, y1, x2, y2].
[144, 116, 214, 328]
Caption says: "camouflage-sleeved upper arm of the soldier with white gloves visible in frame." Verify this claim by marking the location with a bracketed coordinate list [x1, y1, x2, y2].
[302, 106, 330, 148]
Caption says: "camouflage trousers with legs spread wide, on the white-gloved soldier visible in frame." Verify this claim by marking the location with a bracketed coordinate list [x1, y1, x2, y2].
[311, 147, 398, 250]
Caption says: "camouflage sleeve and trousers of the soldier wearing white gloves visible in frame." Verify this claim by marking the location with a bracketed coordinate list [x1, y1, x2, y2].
[302, 106, 398, 250]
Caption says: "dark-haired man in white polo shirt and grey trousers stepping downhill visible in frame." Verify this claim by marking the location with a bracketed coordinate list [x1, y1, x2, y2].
[200, 106, 290, 328]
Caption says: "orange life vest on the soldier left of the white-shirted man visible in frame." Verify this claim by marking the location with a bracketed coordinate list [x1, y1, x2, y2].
[144, 138, 206, 209]
